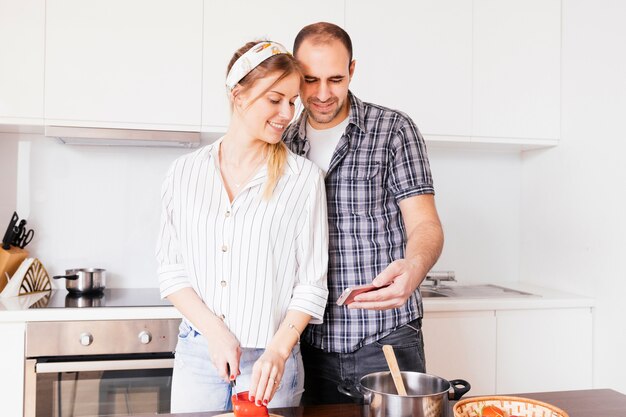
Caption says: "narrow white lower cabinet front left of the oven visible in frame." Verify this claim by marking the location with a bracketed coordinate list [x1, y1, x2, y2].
[0, 323, 28, 416]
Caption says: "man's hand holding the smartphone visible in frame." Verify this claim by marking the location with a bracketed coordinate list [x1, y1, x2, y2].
[348, 259, 424, 310]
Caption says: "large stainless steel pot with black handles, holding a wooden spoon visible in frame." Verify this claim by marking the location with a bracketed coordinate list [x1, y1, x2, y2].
[339, 371, 470, 417]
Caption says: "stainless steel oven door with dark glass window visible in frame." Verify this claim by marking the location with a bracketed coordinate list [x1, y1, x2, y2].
[24, 354, 174, 417]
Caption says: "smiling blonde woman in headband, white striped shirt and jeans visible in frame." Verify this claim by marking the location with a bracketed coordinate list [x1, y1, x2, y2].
[157, 42, 328, 412]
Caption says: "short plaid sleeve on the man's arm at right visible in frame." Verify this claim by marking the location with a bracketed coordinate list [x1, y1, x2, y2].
[389, 114, 435, 201]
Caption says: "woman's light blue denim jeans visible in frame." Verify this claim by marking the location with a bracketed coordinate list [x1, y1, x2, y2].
[171, 320, 304, 413]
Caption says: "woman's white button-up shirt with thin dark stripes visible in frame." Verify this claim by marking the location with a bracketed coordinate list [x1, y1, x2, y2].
[157, 139, 328, 348]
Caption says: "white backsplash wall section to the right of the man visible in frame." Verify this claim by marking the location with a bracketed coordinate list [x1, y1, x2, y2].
[429, 145, 521, 284]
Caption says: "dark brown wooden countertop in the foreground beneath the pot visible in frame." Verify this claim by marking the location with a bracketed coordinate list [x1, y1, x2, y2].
[133, 389, 626, 417]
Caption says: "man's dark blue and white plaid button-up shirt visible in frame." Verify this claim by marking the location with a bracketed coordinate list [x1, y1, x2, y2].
[283, 93, 434, 353]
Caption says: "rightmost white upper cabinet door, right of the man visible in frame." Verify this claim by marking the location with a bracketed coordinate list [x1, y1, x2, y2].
[472, 0, 561, 141]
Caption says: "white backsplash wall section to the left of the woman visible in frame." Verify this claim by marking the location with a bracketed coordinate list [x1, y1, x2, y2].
[0, 134, 187, 287]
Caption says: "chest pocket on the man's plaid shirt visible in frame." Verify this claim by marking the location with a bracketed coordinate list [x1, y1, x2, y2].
[336, 162, 383, 216]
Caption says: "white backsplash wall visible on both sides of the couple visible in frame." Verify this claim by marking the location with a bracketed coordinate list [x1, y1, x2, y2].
[0, 134, 520, 287]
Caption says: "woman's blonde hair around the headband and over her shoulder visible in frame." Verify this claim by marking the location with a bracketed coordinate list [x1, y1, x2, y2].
[226, 40, 303, 200]
